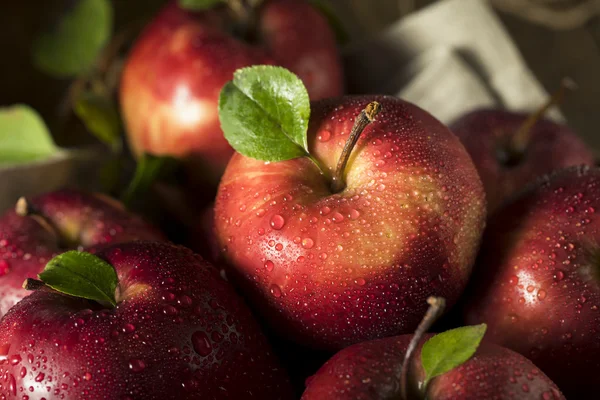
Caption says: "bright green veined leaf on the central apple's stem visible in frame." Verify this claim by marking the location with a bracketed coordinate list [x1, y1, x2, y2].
[219, 65, 310, 161]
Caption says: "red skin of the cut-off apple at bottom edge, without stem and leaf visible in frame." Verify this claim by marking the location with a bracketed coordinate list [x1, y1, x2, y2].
[302, 335, 565, 400]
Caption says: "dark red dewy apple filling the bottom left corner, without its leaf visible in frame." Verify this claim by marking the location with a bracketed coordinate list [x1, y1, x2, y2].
[0, 242, 291, 400]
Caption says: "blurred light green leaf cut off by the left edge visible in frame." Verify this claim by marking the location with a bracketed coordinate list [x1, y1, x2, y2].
[0, 104, 58, 165]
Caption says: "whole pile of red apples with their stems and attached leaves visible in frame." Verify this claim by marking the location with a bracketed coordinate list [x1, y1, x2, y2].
[0, 0, 600, 400]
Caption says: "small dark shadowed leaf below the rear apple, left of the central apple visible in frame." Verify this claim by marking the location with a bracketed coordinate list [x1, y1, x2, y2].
[121, 153, 176, 208]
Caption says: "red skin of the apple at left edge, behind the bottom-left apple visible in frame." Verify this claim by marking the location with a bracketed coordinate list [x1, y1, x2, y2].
[0, 189, 166, 317]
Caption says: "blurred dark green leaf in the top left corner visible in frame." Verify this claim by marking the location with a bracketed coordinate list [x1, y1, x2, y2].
[32, 0, 113, 78]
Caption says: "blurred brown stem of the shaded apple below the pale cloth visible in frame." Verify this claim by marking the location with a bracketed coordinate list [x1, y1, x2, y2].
[500, 78, 577, 166]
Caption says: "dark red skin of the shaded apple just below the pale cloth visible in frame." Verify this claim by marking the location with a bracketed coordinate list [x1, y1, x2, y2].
[450, 109, 595, 215]
